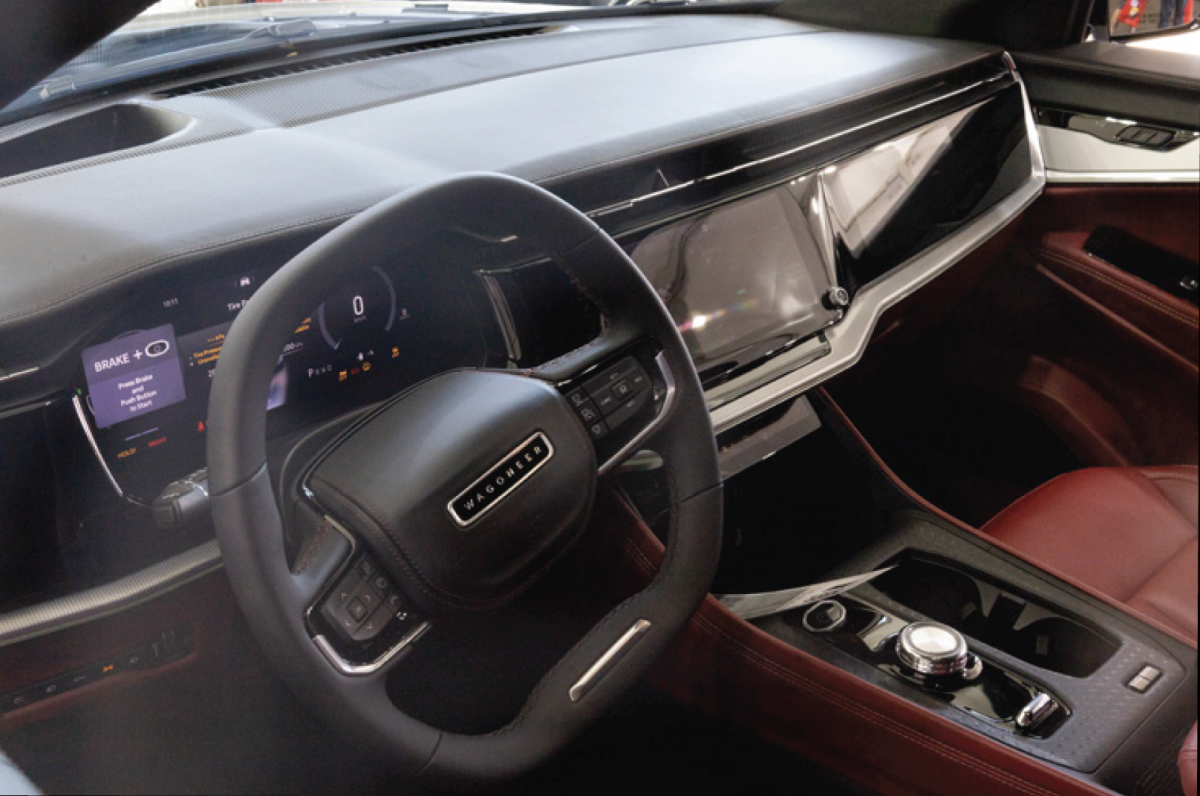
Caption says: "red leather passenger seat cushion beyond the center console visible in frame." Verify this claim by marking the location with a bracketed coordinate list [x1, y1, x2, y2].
[984, 467, 1200, 644]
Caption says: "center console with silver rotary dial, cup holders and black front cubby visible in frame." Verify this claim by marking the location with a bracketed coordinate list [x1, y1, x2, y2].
[700, 396, 1198, 796]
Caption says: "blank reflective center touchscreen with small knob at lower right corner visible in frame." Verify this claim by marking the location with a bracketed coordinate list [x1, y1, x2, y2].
[630, 180, 839, 384]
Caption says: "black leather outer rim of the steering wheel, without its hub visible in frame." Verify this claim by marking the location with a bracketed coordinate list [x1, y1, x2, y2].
[208, 174, 721, 782]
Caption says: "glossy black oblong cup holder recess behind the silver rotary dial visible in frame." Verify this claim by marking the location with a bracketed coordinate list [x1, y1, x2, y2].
[871, 553, 1120, 677]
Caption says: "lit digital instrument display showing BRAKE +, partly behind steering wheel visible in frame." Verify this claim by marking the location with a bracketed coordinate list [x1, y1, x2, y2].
[78, 262, 458, 498]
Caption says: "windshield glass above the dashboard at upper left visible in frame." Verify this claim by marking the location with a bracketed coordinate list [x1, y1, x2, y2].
[11, 0, 720, 115]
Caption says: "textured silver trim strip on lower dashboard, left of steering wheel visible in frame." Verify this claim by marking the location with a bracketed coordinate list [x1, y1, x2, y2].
[0, 539, 222, 647]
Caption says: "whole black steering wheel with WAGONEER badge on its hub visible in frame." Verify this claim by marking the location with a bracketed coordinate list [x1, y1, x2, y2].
[208, 174, 721, 782]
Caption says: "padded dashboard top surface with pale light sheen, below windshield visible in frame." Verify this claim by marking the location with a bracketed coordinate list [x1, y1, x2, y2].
[0, 16, 997, 372]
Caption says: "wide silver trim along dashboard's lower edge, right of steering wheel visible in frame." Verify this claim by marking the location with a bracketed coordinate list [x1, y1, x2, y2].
[710, 78, 1046, 433]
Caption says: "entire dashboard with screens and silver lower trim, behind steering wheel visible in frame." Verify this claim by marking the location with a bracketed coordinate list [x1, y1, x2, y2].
[0, 9, 1044, 635]
